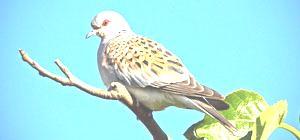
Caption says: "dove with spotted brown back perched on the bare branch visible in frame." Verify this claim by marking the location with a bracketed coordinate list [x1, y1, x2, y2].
[86, 10, 237, 134]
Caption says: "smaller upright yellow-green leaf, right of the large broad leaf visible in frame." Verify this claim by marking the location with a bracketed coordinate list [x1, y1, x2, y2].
[251, 100, 287, 140]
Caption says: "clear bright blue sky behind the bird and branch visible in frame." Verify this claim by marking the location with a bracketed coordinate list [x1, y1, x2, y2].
[0, 0, 300, 140]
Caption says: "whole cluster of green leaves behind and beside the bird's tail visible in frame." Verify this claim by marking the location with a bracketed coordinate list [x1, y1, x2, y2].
[184, 90, 300, 140]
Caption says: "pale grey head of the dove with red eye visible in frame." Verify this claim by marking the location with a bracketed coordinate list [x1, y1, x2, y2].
[86, 11, 131, 40]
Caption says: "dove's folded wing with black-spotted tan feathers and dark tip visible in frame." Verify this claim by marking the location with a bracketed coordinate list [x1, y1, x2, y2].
[105, 35, 224, 100]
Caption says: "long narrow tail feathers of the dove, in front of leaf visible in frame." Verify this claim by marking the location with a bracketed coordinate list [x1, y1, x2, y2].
[191, 99, 240, 136]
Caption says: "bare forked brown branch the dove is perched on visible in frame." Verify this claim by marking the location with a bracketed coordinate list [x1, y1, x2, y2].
[19, 50, 168, 140]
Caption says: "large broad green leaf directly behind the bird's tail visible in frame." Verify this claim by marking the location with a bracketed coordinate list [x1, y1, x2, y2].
[184, 90, 268, 140]
